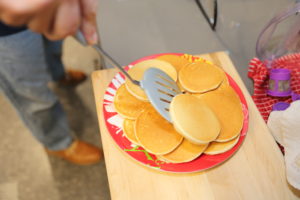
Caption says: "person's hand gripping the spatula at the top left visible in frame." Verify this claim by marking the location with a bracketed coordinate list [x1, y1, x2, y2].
[0, 0, 98, 44]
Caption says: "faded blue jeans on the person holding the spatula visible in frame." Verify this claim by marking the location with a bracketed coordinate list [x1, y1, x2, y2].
[0, 30, 73, 150]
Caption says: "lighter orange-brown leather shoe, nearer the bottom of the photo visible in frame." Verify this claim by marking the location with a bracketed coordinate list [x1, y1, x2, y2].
[46, 140, 103, 165]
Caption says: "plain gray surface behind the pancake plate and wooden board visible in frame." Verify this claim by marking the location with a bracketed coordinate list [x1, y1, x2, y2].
[99, 0, 295, 91]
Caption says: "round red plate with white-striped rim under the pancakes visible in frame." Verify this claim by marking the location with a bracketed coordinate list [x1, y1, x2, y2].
[103, 53, 249, 173]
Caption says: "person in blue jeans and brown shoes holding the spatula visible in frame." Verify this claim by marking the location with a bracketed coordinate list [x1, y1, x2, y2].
[0, 0, 103, 165]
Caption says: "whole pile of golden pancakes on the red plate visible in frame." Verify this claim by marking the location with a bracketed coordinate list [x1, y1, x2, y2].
[114, 55, 244, 163]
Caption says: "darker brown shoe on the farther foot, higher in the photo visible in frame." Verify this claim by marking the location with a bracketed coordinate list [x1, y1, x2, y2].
[58, 69, 87, 86]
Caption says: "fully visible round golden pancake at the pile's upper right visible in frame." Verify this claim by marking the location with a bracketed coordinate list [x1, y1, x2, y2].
[178, 62, 224, 93]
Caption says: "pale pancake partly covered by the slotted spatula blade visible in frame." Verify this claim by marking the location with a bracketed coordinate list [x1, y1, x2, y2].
[125, 59, 177, 101]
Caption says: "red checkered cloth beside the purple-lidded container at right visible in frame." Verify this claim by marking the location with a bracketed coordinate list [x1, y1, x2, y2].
[248, 53, 300, 122]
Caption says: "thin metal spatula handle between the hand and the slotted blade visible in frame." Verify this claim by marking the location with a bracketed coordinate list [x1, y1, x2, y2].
[75, 31, 140, 86]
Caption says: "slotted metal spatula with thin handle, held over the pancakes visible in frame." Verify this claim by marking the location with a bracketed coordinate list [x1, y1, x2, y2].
[75, 32, 181, 123]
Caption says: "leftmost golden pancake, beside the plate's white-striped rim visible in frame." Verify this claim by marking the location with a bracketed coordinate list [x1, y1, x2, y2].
[114, 84, 150, 120]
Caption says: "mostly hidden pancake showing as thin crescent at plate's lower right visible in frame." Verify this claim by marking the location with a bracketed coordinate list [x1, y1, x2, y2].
[204, 137, 240, 155]
